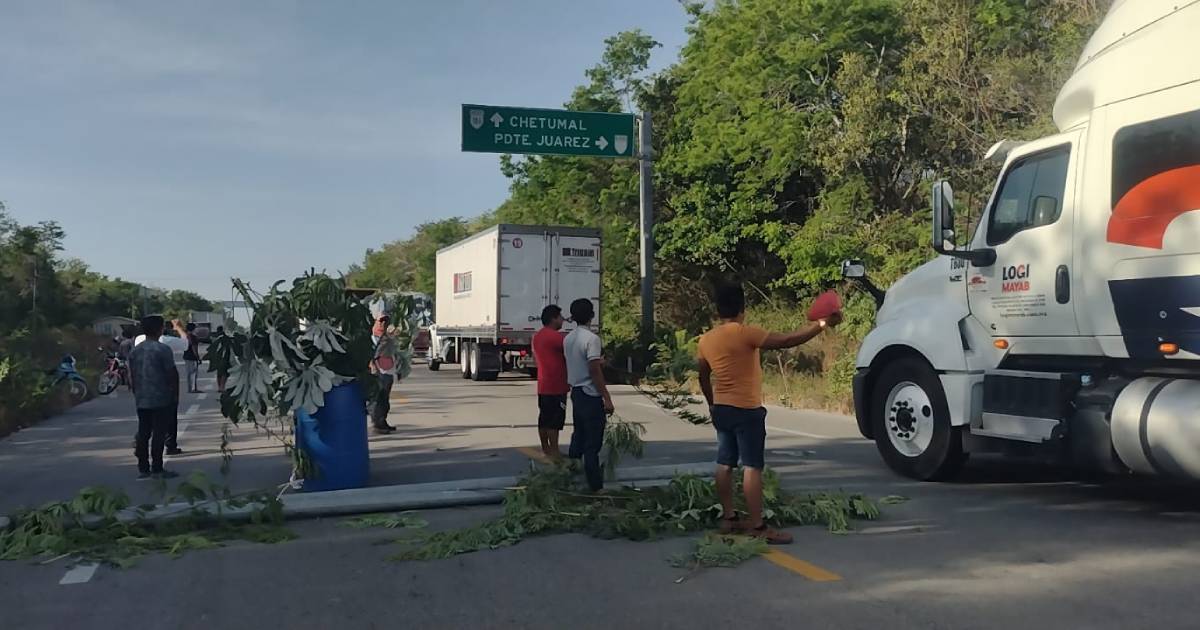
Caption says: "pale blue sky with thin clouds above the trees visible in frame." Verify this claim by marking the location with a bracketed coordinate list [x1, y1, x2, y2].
[0, 0, 688, 299]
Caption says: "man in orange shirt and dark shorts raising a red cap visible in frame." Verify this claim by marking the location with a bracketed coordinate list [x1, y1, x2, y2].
[697, 286, 841, 545]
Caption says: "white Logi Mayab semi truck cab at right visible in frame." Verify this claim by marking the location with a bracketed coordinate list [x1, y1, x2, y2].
[844, 0, 1200, 480]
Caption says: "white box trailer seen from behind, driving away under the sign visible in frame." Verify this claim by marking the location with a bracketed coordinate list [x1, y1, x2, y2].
[430, 223, 602, 380]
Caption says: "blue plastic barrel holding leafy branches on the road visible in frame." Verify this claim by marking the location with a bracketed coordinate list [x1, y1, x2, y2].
[296, 383, 371, 492]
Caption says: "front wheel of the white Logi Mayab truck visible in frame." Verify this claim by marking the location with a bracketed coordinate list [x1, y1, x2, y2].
[871, 358, 966, 481]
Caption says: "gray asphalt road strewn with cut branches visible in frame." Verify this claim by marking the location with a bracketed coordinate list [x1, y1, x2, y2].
[0, 366, 1200, 630]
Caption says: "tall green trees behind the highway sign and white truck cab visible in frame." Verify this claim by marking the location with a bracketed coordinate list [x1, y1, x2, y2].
[350, 0, 1110, 410]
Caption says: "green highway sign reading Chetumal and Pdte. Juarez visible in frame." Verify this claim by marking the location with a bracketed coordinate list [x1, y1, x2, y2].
[462, 104, 634, 157]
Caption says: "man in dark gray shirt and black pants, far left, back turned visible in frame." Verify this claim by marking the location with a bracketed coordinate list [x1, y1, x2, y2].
[130, 316, 179, 479]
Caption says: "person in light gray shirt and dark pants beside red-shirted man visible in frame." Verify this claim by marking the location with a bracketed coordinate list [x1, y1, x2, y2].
[563, 298, 613, 492]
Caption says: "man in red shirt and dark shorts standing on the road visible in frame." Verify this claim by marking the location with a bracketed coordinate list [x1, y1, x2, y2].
[533, 304, 571, 460]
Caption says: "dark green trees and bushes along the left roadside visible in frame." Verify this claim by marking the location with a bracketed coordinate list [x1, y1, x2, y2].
[0, 203, 214, 437]
